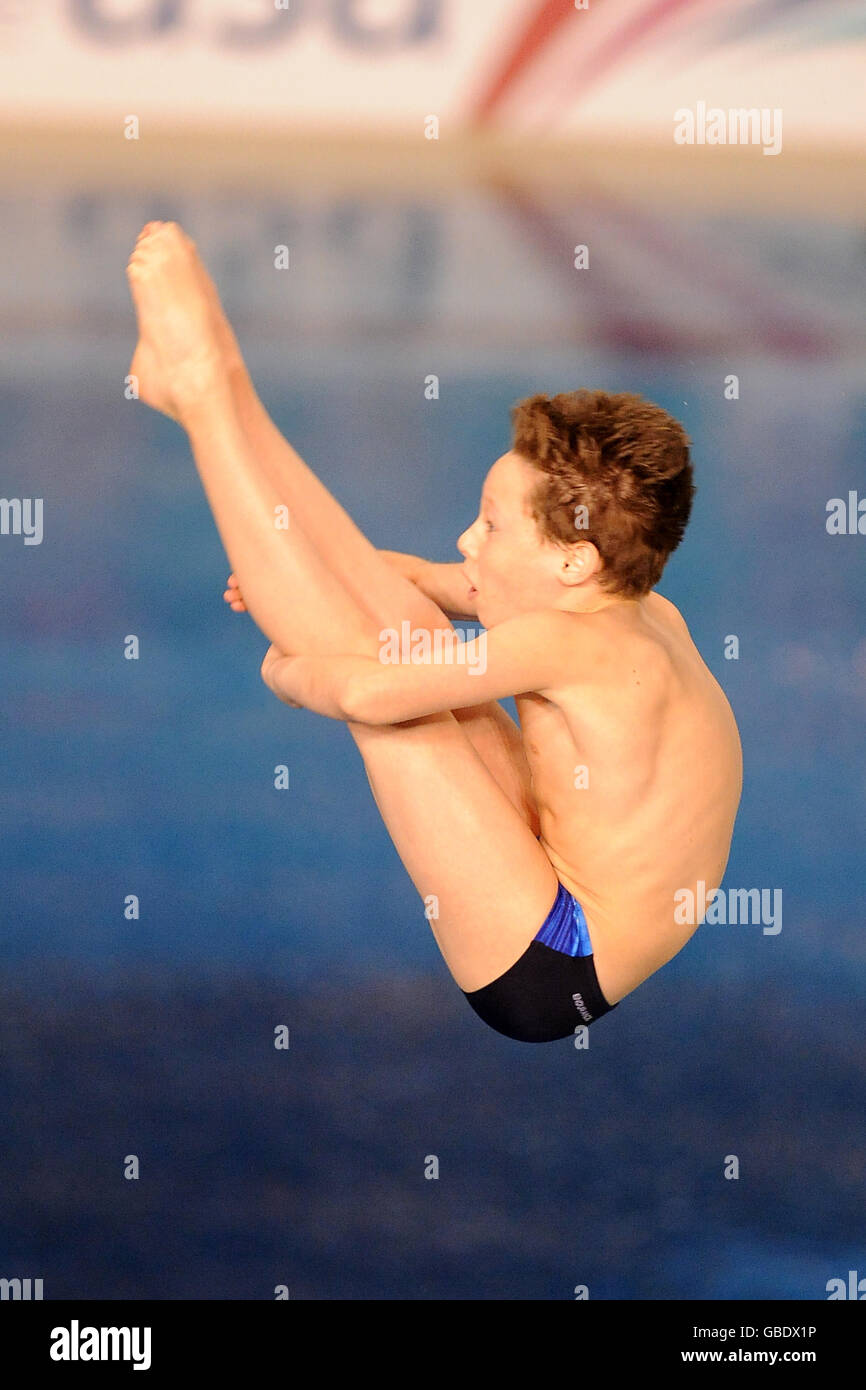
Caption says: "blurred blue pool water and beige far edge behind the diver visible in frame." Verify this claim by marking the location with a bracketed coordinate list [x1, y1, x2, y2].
[0, 0, 866, 1300]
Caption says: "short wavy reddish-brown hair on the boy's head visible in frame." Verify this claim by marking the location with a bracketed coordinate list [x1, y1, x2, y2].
[512, 389, 696, 598]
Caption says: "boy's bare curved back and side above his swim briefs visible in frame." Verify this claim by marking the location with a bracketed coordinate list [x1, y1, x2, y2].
[516, 594, 742, 1004]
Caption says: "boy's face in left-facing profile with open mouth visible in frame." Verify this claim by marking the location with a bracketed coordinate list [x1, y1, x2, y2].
[457, 453, 564, 627]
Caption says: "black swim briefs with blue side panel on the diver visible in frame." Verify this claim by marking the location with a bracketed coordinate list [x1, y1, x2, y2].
[463, 883, 619, 1043]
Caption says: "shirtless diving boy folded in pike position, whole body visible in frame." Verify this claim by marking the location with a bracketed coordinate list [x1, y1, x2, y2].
[128, 222, 742, 1043]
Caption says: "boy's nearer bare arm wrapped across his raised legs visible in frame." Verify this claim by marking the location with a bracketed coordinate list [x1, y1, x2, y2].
[263, 609, 587, 724]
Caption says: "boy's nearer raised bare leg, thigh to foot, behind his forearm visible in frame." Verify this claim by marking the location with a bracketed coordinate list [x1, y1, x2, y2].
[133, 232, 557, 992]
